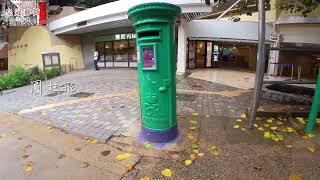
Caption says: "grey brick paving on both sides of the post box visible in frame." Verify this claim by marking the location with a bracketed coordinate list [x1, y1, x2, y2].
[0, 69, 249, 142]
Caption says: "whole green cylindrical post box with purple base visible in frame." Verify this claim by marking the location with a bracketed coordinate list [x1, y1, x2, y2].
[128, 3, 181, 143]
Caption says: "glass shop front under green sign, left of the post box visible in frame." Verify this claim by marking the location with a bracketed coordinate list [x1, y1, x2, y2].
[96, 33, 137, 68]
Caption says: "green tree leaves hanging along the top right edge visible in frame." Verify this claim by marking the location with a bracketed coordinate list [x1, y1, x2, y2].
[204, 0, 320, 17]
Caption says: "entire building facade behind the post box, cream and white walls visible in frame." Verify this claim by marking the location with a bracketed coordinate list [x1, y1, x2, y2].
[8, 0, 320, 80]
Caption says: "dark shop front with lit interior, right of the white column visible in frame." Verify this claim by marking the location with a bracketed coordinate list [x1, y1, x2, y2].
[187, 39, 257, 70]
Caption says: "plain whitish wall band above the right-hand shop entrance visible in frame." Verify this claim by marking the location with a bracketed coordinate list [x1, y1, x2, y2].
[186, 19, 273, 41]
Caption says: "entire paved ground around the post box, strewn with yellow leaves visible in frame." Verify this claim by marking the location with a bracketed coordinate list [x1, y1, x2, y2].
[0, 69, 320, 180]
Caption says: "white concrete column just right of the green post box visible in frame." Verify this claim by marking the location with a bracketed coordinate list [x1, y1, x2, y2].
[177, 20, 187, 75]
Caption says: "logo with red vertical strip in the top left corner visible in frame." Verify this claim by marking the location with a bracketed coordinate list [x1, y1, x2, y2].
[1, 0, 47, 26]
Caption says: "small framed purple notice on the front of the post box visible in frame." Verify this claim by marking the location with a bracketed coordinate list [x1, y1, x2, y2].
[142, 45, 157, 70]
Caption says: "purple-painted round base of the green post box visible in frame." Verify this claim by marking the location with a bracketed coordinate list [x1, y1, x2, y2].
[140, 126, 178, 143]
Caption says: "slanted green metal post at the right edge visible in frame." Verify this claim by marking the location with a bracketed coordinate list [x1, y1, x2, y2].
[306, 69, 320, 133]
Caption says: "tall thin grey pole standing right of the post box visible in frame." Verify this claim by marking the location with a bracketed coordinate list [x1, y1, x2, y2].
[249, 0, 266, 128]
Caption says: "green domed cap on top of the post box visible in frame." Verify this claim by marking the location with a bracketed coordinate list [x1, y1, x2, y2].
[128, 2, 181, 21]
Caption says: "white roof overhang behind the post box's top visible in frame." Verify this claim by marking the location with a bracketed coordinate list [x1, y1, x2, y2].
[49, 0, 212, 34]
